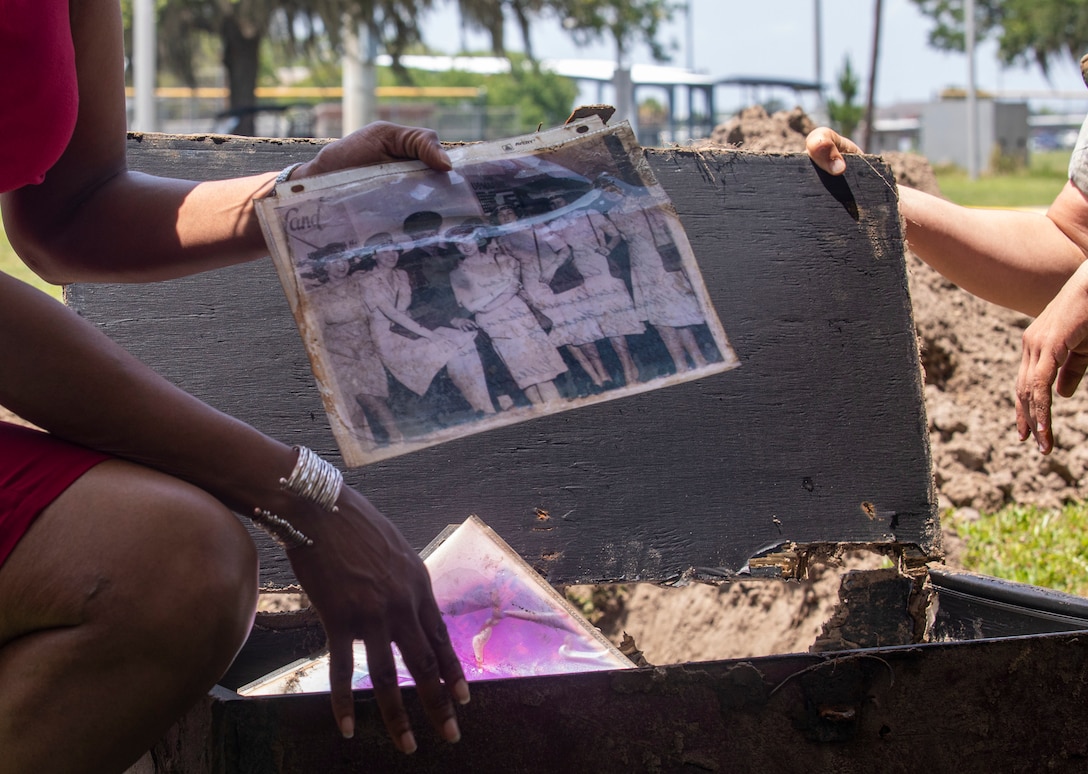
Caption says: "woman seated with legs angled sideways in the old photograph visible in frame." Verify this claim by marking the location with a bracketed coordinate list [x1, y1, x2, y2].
[355, 232, 495, 414]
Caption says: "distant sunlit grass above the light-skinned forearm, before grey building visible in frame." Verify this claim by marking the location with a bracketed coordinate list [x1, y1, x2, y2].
[934, 150, 1070, 207]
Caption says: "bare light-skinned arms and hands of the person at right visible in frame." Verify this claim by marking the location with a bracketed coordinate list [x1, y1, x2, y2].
[806, 127, 1088, 454]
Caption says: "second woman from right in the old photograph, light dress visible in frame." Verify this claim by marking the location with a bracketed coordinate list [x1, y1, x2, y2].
[541, 195, 646, 384]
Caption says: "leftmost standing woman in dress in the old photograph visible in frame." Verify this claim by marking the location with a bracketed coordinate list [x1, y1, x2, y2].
[316, 254, 404, 444]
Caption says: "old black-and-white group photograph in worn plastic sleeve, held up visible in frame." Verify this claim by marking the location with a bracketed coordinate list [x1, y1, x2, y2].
[257, 118, 739, 467]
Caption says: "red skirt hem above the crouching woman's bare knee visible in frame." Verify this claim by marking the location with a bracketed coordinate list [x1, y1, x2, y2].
[0, 422, 109, 566]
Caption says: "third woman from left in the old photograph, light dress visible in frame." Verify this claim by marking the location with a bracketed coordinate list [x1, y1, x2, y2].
[446, 224, 567, 405]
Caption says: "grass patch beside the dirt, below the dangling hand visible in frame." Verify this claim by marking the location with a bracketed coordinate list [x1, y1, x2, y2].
[945, 503, 1088, 597]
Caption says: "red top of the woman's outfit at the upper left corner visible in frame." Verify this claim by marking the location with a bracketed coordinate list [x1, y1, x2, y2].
[0, 0, 79, 192]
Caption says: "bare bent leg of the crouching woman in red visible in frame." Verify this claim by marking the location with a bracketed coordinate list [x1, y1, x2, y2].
[0, 460, 257, 774]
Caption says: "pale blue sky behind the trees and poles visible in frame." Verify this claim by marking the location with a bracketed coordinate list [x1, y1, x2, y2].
[424, 0, 1088, 113]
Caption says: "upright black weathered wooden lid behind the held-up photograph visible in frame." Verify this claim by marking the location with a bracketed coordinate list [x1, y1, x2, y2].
[69, 135, 938, 588]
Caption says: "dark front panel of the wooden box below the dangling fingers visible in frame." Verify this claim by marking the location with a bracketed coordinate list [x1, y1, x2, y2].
[160, 634, 1088, 774]
